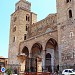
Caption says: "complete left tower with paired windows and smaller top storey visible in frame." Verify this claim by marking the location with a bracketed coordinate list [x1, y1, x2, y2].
[8, 0, 37, 64]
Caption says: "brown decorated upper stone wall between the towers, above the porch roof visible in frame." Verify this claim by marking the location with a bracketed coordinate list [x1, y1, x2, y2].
[30, 14, 57, 37]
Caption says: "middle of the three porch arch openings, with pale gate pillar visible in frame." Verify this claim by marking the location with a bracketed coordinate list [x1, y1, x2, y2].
[31, 43, 43, 72]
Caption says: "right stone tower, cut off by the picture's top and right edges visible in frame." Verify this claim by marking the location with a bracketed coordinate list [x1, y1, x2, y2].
[56, 0, 75, 70]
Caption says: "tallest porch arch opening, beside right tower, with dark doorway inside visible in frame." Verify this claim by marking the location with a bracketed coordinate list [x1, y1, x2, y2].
[45, 38, 59, 72]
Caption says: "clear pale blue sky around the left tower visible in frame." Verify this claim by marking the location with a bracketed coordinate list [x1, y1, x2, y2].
[0, 0, 56, 57]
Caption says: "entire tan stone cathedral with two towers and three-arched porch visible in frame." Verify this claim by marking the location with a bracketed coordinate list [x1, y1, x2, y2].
[8, 0, 75, 72]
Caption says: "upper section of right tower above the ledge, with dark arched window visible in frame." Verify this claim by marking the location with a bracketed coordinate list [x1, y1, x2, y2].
[56, 0, 75, 23]
